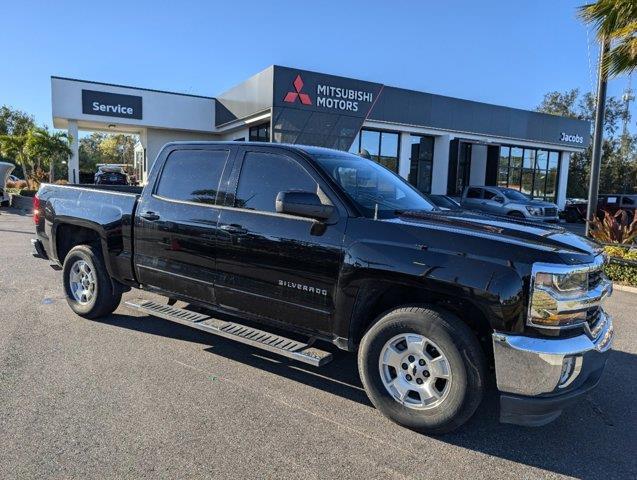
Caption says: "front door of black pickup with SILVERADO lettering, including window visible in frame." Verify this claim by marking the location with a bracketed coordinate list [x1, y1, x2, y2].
[216, 146, 347, 332]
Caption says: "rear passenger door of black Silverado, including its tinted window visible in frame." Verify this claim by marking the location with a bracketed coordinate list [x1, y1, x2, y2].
[133, 145, 236, 303]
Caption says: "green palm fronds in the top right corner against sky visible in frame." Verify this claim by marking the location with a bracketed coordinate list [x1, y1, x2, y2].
[579, 0, 637, 77]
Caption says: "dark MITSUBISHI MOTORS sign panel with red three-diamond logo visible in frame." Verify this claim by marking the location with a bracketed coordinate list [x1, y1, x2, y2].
[274, 67, 382, 117]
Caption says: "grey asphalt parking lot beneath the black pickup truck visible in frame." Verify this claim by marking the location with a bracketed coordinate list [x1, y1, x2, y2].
[0, 209, 637, 479]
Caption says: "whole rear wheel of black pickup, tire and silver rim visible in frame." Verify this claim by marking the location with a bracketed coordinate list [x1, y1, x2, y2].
[62, 245, 122, 318]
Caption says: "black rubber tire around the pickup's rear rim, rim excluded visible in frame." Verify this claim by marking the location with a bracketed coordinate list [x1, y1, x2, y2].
[62, 245, 122, 319]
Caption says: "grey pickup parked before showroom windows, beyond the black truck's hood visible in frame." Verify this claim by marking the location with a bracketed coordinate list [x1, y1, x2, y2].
[460, 187, 559, 222]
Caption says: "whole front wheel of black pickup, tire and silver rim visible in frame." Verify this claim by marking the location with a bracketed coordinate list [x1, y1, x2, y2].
[358, 307, 486, 434]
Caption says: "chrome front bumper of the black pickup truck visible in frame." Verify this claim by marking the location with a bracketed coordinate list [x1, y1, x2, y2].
[493, 310, 614, 396]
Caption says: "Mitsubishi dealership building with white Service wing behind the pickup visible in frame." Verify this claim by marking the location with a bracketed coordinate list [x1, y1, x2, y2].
[51, 65, 590, 207]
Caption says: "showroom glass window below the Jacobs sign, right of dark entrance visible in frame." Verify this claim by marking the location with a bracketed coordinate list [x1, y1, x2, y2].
[498, 145, 560, 201]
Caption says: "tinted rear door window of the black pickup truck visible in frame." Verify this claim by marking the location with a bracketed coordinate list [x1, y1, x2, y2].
[155, 150, 229, 204]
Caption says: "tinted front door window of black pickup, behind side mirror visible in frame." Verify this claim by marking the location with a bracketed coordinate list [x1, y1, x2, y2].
[235, 152, 317, 212]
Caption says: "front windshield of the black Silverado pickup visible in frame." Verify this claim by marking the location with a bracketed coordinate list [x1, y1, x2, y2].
[312, 153, 435, 218]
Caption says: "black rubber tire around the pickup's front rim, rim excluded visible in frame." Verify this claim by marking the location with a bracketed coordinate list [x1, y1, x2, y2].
[358, 307, 486, 434]
